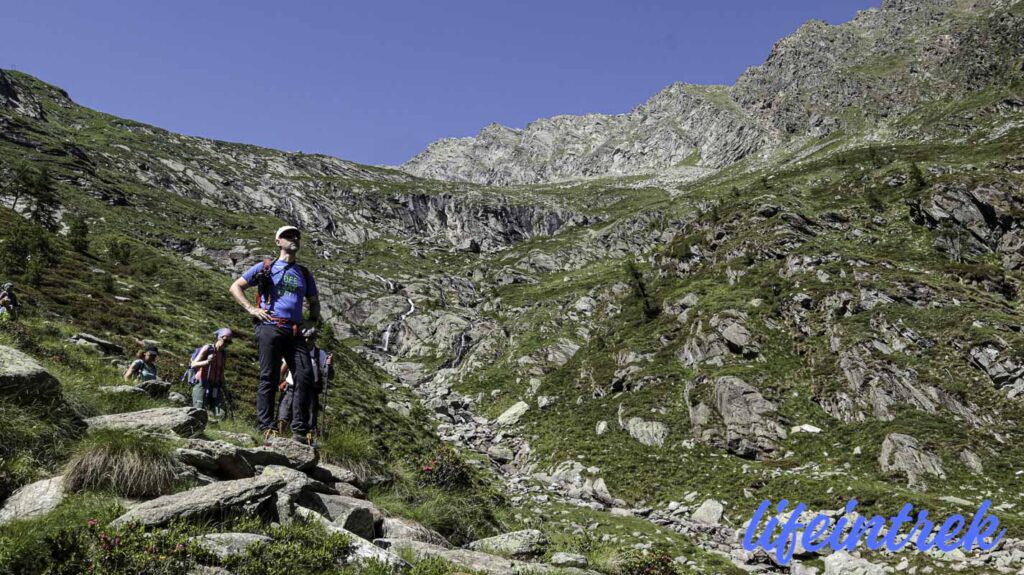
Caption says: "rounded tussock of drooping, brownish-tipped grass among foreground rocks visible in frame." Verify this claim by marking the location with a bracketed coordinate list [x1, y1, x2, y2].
[65, 430, 177, 497]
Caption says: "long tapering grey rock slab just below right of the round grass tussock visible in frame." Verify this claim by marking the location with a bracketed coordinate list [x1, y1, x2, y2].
[111, 477, 286, 527]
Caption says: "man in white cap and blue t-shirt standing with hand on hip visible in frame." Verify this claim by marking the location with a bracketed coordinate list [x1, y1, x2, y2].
[228, 225, 319, 445]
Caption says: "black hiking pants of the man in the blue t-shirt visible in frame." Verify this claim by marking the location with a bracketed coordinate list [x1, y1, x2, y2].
[256, 323, 313, 437]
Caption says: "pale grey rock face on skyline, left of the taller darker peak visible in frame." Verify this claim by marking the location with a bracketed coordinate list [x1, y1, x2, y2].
[402, 83, 770, 185]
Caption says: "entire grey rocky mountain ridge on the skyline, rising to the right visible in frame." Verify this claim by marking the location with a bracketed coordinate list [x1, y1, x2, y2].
[400, 0, 1024, 185]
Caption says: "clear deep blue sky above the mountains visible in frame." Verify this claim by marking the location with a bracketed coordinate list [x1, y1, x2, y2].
[0, 0, 880, 164]
